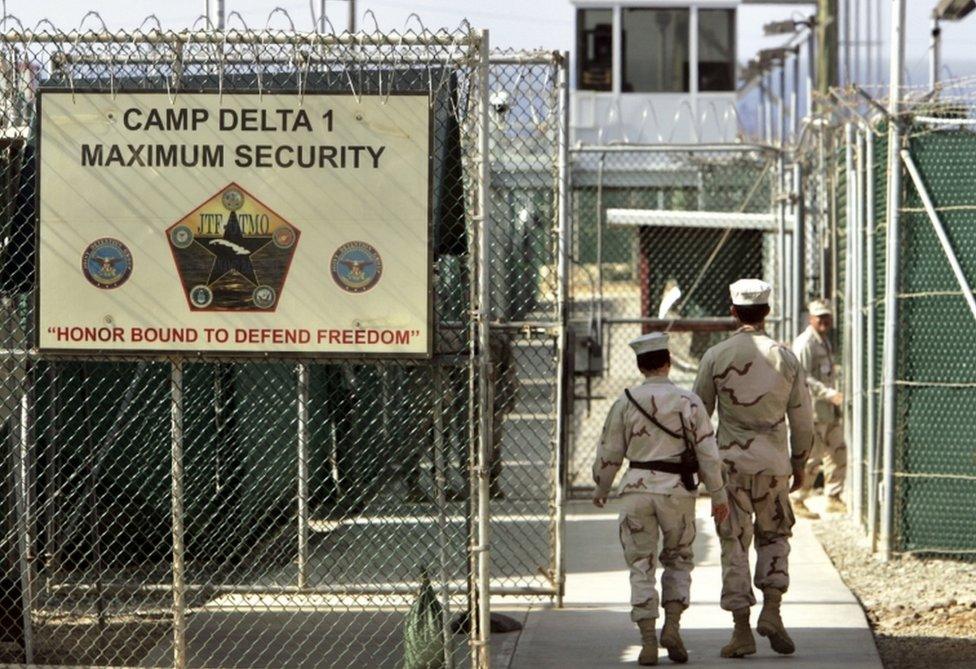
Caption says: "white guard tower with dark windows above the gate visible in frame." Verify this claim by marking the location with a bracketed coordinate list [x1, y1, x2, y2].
[570, 0, 739, 144]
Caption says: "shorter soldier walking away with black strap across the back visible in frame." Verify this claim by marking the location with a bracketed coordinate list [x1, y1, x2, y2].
[593, 333, 729, 665]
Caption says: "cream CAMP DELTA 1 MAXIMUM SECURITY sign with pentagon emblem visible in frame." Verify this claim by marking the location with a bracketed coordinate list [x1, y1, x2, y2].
[37, 91, 431, 356]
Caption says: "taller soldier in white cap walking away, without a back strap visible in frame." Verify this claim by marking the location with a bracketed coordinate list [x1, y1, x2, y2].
[694, 279, 813, 657]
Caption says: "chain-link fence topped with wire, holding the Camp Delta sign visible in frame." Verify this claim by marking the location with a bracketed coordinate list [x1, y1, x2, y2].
[0, 17, 565, 667]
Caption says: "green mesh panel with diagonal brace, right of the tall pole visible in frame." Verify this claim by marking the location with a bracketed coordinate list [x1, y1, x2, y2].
[895, 117, 976, 553]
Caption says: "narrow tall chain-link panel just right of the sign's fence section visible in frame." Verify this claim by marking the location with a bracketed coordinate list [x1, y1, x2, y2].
[489, 53, 567, 596]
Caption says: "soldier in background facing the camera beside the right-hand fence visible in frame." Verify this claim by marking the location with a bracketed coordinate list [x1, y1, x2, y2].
[793, 300, 847, 518]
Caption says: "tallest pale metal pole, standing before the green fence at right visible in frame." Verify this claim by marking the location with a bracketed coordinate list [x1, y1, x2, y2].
[881, 0, 905, 561]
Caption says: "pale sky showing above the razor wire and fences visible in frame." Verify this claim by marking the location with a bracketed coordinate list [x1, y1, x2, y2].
[5, 0, 976, 83]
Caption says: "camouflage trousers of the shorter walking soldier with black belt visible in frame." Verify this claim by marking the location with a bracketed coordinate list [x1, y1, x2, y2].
[620, 493, 695, 622]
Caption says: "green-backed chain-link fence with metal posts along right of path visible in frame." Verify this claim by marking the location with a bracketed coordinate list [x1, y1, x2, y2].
[831, 82, 976, 556]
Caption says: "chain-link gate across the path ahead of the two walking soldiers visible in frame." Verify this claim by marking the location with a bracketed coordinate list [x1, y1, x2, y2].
[569, 146, 776, 487]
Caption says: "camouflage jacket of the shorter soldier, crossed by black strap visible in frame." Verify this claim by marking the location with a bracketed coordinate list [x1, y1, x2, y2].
[593, 376, 726, 504]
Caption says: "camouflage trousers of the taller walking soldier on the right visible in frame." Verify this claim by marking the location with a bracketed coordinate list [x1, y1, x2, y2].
[718, 474, 795, 611]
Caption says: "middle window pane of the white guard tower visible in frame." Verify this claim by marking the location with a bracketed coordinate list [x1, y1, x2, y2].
[621, 8, 690, 93]
